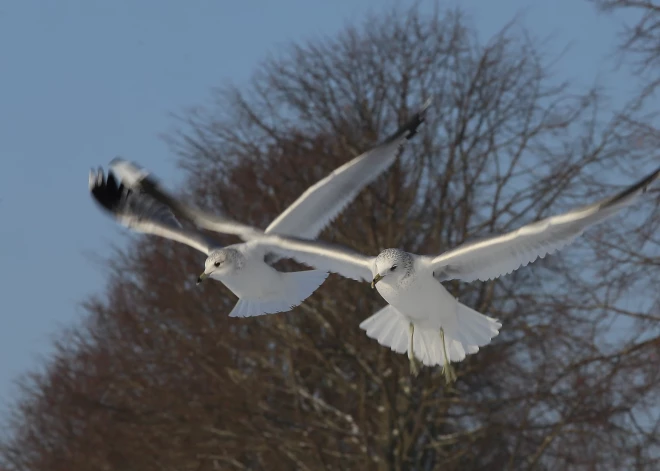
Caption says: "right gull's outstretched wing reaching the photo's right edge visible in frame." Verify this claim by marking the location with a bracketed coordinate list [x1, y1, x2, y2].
[431, 168, 660, 281]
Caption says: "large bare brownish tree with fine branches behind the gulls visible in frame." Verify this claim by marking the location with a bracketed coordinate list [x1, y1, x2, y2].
[0, 0, 660, 471]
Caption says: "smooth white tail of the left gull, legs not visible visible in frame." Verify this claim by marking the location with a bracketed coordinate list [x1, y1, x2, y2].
[229, 270, 328, 317]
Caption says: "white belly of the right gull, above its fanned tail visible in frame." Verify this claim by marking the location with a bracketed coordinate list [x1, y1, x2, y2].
[376, 274, 458, 330]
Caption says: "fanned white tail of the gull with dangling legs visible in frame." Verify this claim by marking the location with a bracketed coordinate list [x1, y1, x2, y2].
[360, 301, 502, 366]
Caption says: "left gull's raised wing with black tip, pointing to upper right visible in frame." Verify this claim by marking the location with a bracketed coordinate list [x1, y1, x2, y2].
[264, 99, 431, 239]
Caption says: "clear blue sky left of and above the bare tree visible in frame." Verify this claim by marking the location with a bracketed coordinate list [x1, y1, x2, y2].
[0, 0, 630, 407]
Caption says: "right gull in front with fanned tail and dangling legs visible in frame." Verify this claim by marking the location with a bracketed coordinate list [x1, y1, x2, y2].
[135, 159, 660, 384]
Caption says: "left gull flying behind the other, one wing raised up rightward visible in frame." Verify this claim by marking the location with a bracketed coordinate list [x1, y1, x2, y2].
[89, 100, 431, 317]
